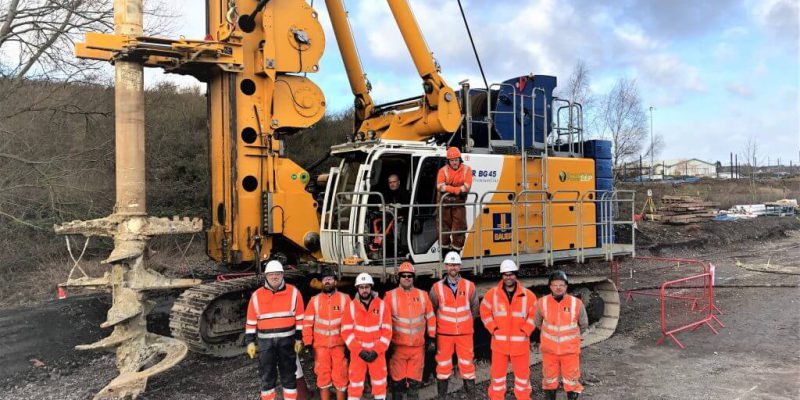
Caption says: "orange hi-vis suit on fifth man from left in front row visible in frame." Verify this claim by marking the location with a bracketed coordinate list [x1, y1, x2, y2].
[430, 277, 478, 379]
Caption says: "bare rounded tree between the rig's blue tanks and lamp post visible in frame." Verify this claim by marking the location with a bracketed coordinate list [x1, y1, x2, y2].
[601, 78, 647, 168]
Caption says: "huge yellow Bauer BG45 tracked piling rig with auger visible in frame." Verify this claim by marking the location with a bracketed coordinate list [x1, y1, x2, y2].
[56, 0, 634, 399]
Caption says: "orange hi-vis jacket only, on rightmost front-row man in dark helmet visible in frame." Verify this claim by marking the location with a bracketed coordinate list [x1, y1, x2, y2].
[537, 294, 583, 355]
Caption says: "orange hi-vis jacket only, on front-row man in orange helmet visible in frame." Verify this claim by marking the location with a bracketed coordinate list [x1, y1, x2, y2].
[383, 287, 436, 346]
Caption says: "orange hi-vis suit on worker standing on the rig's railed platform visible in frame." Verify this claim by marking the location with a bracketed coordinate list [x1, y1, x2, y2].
[436, 163, 472, 250]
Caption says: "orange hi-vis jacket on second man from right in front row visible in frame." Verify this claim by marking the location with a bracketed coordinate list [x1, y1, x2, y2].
[481, 281, 536, 355]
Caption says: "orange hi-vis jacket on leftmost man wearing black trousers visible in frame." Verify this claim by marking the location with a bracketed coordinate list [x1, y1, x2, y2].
[245, 284, 304, 343]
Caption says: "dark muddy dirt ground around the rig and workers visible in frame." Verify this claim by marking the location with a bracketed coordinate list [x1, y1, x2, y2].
[0, 218, 800, 400]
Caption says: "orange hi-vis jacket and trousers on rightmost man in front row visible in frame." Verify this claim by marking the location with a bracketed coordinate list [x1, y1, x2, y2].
[535, 294, 589, 393]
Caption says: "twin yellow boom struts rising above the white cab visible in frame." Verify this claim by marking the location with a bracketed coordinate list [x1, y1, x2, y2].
[325, 0, 461, 140]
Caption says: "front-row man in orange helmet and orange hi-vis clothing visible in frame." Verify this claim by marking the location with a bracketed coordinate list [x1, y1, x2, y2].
[383, 261, 436, 400]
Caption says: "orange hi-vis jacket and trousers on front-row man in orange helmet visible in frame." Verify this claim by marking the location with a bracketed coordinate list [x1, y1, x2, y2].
[383, 287, 436, 382]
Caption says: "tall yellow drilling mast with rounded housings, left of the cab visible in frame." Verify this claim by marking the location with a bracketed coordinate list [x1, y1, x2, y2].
[76, 0, 326, 264]
